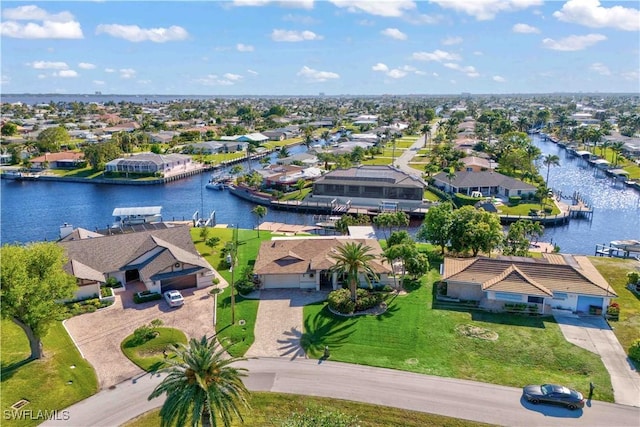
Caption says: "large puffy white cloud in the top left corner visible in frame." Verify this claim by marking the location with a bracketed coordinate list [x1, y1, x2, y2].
[0, 5, 84, 39]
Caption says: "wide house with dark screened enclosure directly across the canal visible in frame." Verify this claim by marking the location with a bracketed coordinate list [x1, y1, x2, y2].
[313, 165, 426, 202]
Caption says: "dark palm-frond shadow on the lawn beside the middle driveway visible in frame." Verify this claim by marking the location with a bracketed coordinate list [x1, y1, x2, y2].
[299, 306, 357, 358]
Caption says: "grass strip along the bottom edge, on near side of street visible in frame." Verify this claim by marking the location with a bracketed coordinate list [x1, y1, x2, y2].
[124, 392, 487, 427]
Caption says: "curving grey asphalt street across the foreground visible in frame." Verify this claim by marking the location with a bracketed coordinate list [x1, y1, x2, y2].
[42, 358, 640, 427]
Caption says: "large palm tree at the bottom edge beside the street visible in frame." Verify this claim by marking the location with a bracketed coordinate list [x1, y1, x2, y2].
[148, 336, 249, 427]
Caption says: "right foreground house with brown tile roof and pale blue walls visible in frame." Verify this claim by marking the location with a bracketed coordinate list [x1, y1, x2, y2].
[440, 253, 618, 314]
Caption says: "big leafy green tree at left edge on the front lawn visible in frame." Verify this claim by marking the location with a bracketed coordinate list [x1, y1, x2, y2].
[0, 243, 76, 359]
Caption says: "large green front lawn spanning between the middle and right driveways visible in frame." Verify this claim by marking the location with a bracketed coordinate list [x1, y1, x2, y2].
[303, 270, 613, 402]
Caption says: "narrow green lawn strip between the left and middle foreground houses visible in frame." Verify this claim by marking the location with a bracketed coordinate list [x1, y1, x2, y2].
[191, 228, 271, 356]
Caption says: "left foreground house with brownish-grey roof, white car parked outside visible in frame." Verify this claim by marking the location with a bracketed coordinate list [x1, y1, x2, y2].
[58, 226, 214, 298]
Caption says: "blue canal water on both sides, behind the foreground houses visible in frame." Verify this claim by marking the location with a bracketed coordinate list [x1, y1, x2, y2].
[0, 136, 640, 255]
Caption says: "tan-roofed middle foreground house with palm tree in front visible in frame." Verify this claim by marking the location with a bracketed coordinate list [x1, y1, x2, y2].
[253, 237, 393, 291]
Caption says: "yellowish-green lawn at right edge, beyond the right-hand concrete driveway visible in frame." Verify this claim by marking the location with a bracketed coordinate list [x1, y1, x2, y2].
[589, 257, 640, 370]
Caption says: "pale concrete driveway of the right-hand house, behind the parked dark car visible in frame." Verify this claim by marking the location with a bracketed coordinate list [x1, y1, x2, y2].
[554, 315, 640, 406]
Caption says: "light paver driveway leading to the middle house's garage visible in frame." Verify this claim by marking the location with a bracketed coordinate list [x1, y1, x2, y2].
[245, 289, 328, 359]
